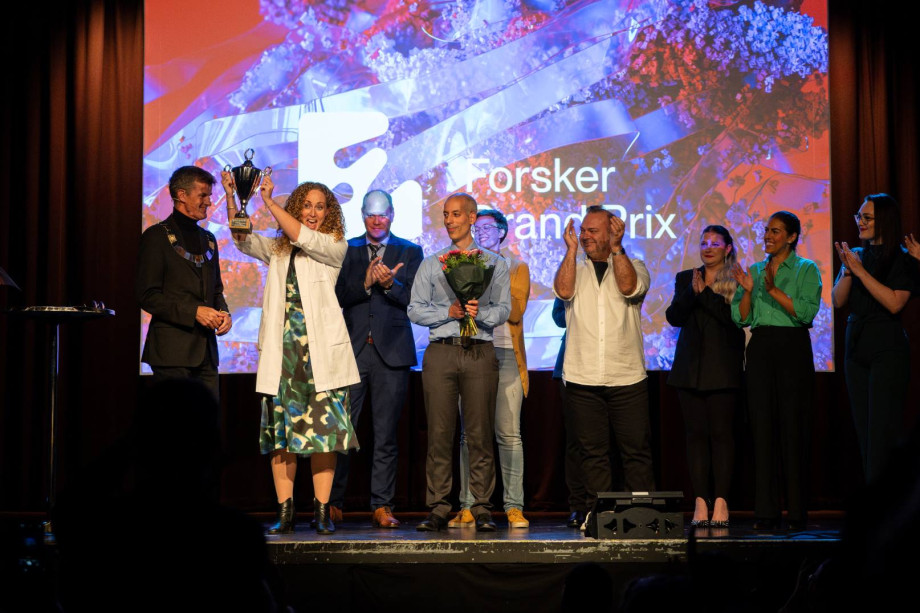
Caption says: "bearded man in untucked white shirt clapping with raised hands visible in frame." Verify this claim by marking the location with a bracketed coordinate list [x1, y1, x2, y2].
[553, 206, 655, 507]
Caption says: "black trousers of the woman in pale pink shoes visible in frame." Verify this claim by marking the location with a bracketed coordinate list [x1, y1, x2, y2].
[677, 389, 738, 500]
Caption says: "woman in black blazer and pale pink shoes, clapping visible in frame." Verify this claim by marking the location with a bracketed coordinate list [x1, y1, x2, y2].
[665, 225, 744, 527]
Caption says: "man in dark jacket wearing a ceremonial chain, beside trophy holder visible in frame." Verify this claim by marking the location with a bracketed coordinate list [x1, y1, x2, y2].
[135, 166, 232, 397]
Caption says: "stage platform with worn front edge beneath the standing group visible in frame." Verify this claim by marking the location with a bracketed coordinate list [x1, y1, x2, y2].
[259, 513, 843, 613]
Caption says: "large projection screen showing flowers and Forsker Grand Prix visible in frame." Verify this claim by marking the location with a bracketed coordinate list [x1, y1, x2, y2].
[143, 0, 834, 372]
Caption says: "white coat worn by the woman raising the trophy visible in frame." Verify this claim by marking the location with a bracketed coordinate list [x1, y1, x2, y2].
[234, 225, 361, 396]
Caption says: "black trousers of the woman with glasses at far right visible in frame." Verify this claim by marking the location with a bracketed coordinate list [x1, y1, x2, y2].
[845, 320, 910, 483]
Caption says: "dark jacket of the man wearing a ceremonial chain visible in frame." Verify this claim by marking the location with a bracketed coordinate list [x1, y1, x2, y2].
[134, 213, 229, 368]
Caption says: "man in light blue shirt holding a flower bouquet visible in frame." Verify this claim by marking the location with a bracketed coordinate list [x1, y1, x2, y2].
[408, 193, 511, 531]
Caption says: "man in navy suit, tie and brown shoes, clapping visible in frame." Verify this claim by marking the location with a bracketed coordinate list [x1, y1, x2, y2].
[330, 190, 422, 528]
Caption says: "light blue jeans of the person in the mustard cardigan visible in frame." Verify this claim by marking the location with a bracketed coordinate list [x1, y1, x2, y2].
[460, 347, 524, 511]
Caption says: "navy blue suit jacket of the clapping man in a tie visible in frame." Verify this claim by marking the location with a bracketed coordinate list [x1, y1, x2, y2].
[335, 234, 422, 368]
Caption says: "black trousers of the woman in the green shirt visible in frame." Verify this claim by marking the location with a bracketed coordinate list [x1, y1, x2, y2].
[746, 326, 815, 523]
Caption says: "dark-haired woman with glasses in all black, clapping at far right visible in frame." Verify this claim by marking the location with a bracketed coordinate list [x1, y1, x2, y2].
[833, 194, 918, 482]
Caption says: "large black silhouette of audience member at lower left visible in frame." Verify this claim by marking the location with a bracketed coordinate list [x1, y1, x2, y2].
[55, 380, 280, 611]
